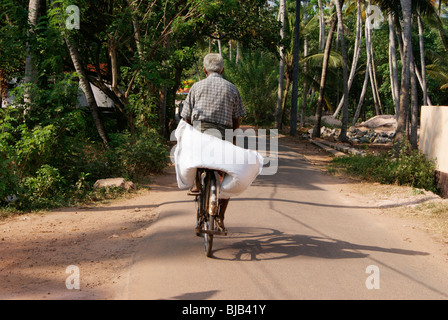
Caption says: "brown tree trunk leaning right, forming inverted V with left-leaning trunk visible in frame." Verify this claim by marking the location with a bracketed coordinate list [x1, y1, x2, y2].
[312, 15, 337, 138]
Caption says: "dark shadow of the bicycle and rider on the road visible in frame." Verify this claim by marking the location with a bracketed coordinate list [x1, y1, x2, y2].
[211, 228, 429, 261]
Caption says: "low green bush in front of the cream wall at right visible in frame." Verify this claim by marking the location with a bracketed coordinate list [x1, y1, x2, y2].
[331, 144, 438, 193]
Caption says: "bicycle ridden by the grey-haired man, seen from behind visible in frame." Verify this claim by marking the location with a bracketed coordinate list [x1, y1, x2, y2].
[195, 168, 227, 257]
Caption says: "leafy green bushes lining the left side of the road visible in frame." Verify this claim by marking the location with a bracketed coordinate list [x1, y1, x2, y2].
[0, 108, 169, 211]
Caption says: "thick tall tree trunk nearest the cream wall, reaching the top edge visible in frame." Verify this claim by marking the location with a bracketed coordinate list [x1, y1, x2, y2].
[394, 0, 412, 148]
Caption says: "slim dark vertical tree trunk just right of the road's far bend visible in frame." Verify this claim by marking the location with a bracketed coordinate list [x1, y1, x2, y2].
[289, 0, 301, 137]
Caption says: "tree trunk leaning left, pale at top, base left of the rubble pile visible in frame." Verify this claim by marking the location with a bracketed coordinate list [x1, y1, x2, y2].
[335, 0, 348, 142]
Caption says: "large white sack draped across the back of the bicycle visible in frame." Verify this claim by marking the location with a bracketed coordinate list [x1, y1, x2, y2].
[174, 120, 263, 199]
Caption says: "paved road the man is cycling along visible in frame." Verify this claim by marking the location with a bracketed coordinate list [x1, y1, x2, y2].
[126, 139, 448, 300]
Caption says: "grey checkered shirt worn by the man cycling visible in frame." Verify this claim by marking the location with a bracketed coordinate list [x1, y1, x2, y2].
[181, 73, 246, 128]
